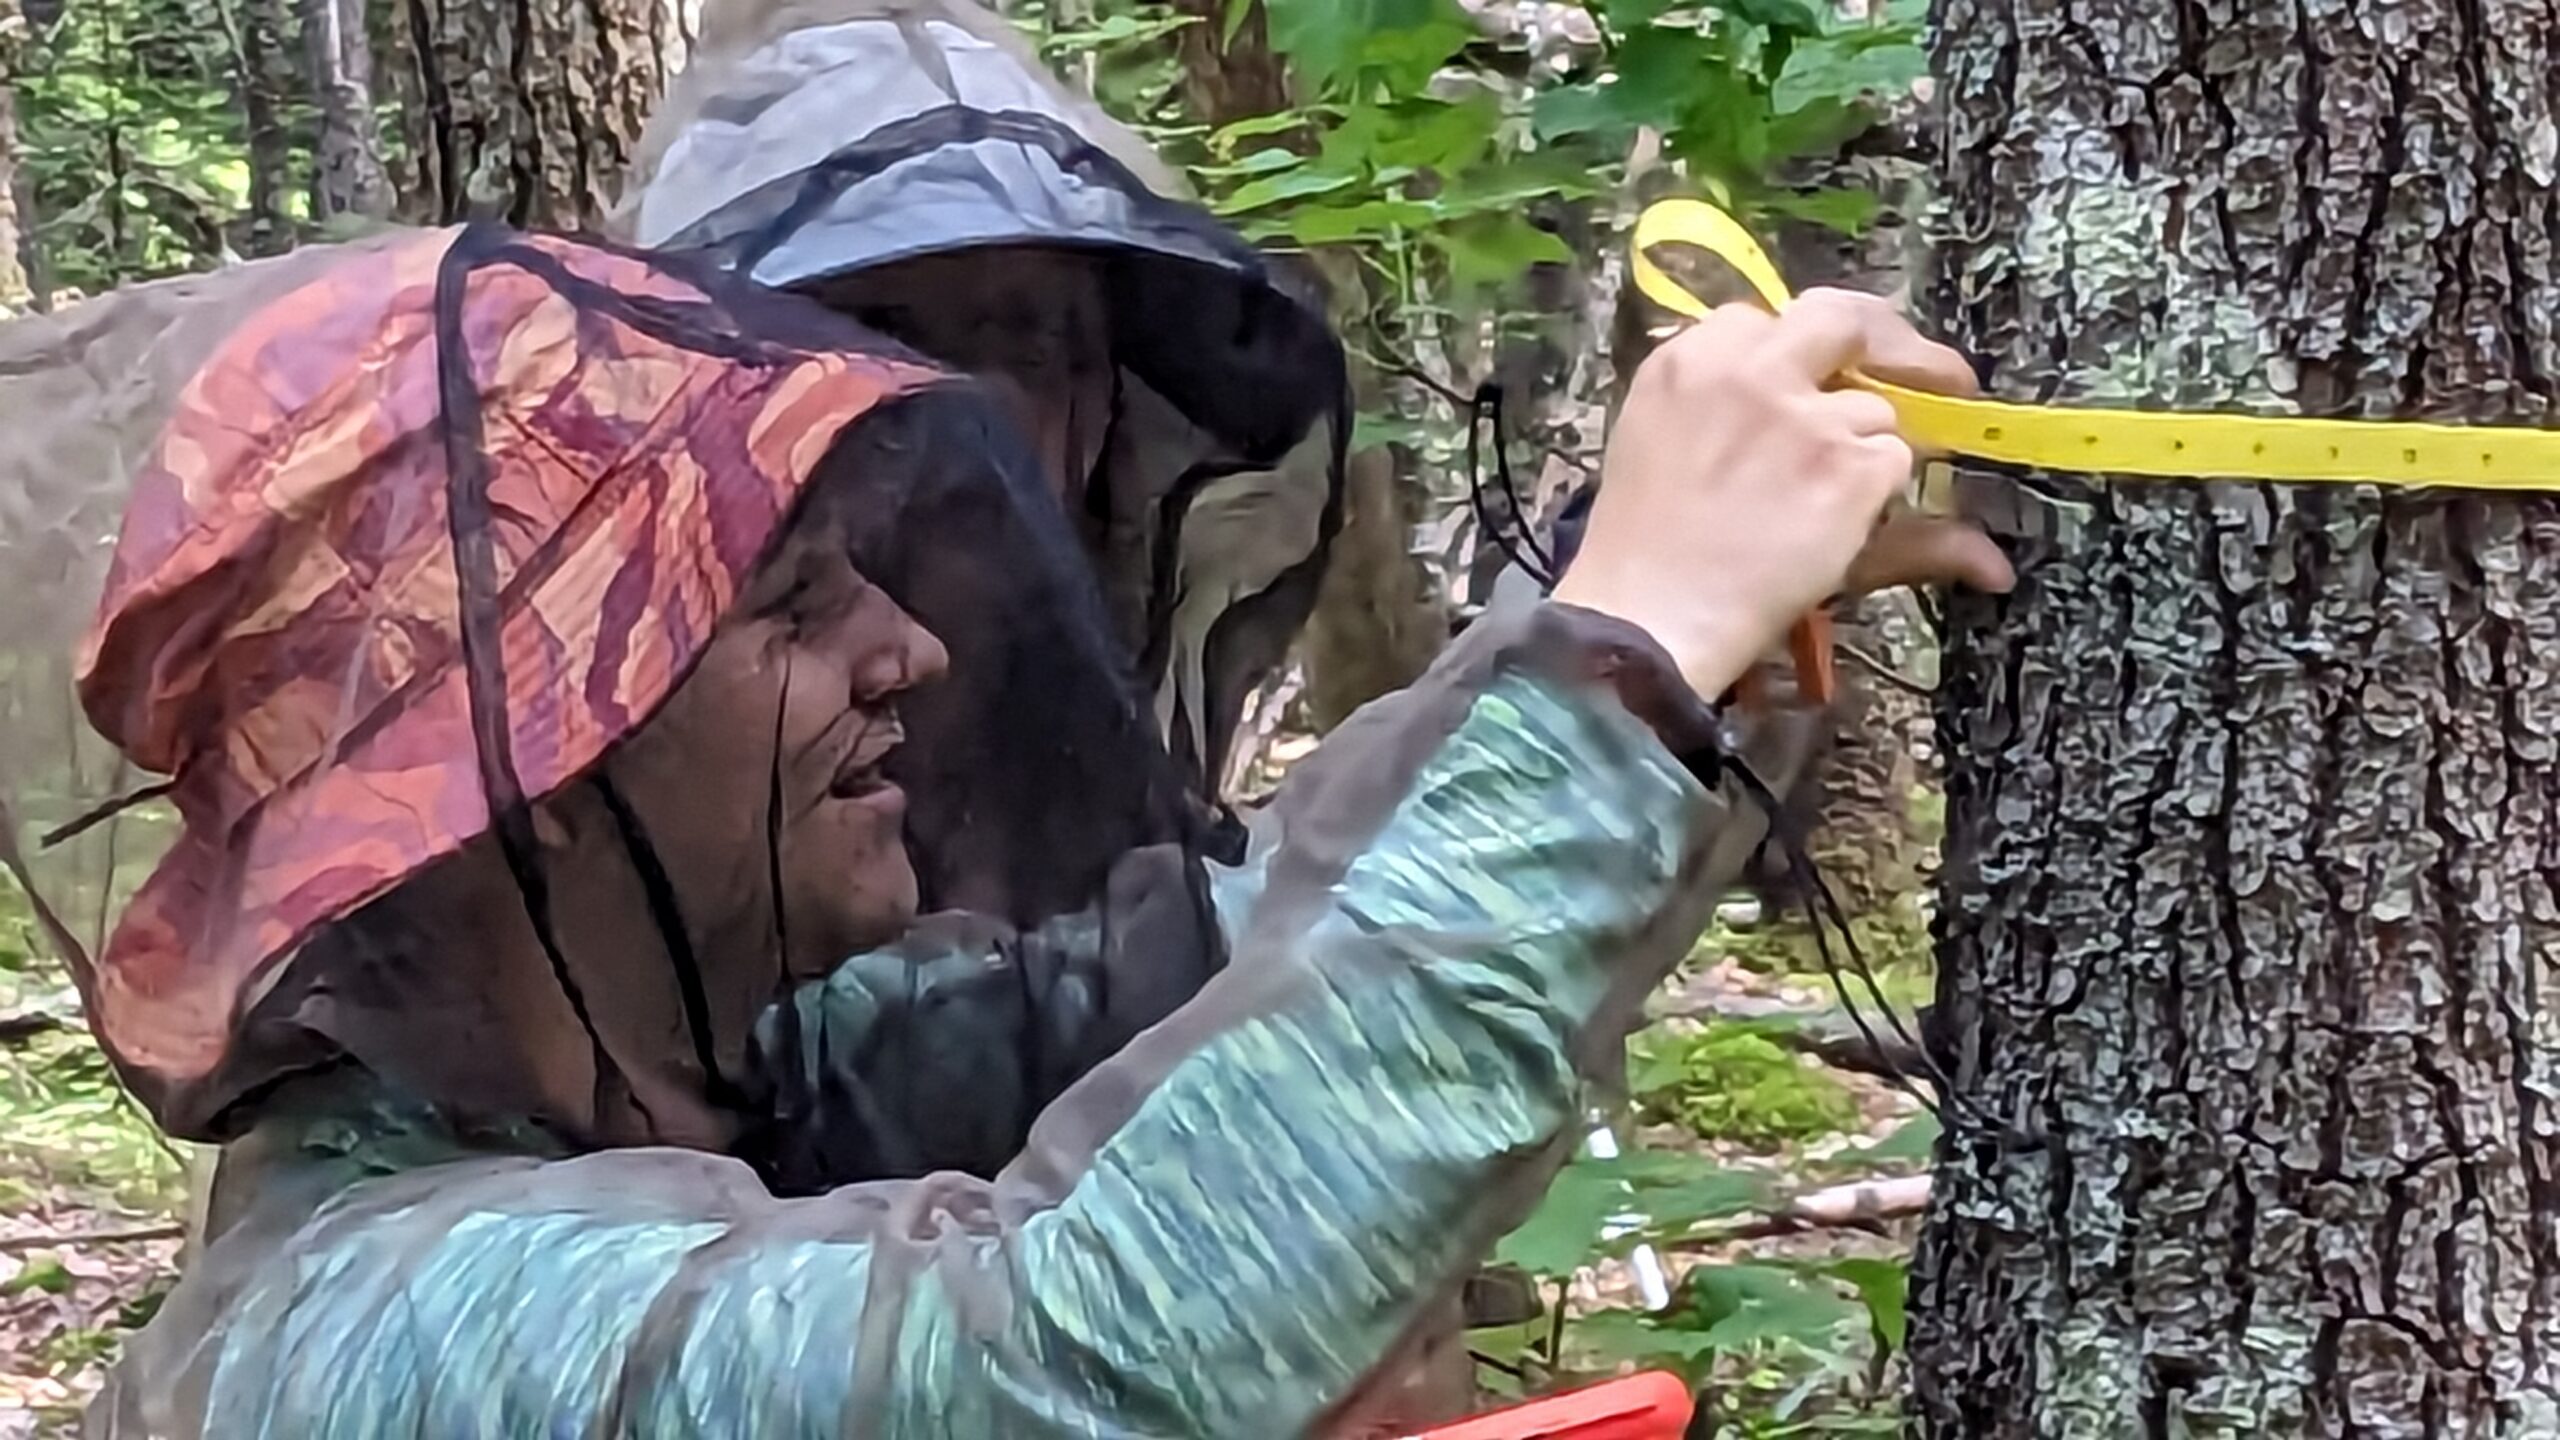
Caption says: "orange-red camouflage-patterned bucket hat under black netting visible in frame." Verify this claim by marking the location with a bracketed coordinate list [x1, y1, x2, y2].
[79, 228, 937, 1133]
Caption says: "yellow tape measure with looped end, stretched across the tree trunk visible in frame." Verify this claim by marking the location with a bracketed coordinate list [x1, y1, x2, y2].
[1633, 200, 2560, 489]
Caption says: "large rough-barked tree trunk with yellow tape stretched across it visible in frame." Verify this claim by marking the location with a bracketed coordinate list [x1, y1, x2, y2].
[1912, 0, 2560, 1440]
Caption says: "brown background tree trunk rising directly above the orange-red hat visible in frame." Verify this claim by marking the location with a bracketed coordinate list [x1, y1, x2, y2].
[394, 0, 673, 231]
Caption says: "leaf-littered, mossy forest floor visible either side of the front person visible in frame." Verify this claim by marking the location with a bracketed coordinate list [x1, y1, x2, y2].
[0, 881, 1928, 1440]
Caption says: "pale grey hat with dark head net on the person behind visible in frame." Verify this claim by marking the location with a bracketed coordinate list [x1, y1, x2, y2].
[612, 0, 1349, 794]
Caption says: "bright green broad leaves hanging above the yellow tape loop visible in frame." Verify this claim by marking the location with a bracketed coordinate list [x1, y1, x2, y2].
[1203, 0, 1923, 287]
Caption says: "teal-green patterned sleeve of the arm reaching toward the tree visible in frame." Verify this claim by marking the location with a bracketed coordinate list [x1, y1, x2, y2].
[95, 597, 1812, 1440]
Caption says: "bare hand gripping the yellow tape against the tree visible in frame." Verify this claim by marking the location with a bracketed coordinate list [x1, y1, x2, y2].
[1554, 290, 2012, 697]
